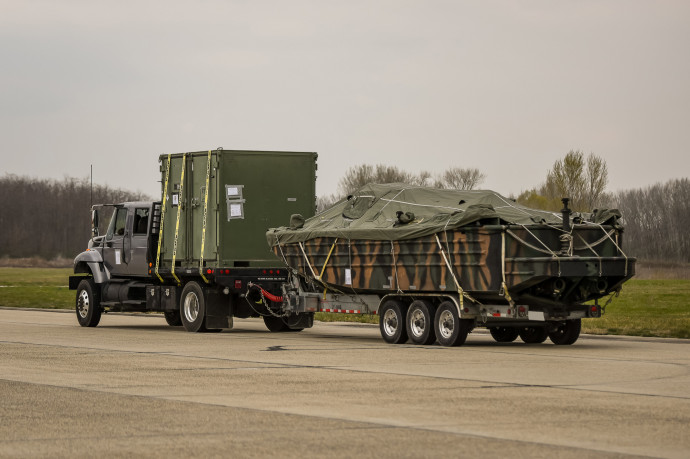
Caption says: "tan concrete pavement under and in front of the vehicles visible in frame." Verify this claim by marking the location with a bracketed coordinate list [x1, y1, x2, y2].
[0, 309, 690, 458]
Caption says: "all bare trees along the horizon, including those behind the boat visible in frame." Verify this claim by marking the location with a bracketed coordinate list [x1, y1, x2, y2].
[0, 151, 690, 263]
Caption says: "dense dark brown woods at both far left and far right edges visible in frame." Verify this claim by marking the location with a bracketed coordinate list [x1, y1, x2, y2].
[0, 175, 690, 263]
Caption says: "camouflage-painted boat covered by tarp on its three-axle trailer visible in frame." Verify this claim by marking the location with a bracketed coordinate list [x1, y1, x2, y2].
[267, 184, 635, 344]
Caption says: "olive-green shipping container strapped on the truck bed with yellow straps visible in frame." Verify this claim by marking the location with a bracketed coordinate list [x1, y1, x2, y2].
[157, 149, 317, 270]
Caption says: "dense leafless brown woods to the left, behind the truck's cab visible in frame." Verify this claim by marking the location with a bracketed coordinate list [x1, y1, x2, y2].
[0, 174, 149, 259]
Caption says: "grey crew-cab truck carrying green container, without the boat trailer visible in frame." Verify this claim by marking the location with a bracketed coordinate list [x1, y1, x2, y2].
[69, 148, 318, 332]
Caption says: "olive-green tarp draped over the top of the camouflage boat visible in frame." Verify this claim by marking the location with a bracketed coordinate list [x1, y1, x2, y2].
[266, 183, 562, 247]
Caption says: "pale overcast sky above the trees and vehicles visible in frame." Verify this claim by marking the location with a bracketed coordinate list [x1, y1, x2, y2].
[0, 0, 690, 196]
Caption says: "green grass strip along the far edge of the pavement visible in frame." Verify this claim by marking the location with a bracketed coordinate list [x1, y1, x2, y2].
[0, 268, 690, 339]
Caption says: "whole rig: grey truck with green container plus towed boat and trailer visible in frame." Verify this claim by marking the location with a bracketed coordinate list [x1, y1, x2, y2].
[69, 149, 636, 346]
